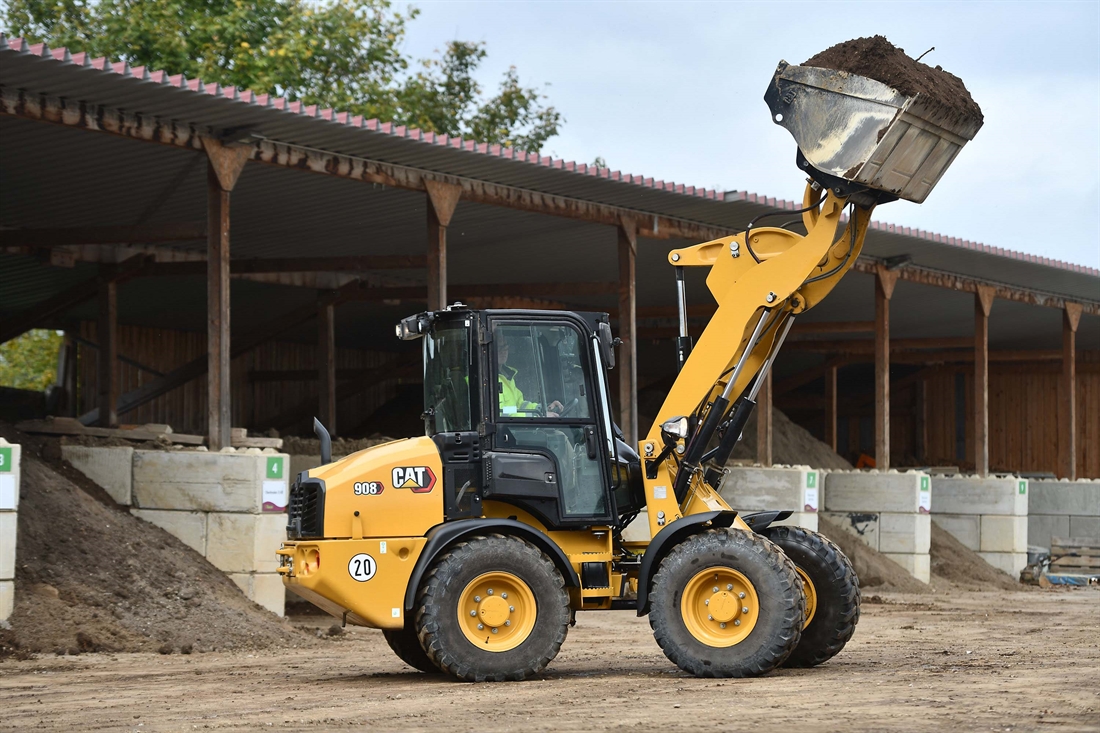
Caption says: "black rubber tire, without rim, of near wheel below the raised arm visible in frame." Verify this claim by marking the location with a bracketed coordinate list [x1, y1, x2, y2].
[649, 529, 805, 677]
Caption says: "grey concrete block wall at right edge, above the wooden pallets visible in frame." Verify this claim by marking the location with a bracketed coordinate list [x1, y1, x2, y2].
[1027, 479, 1100, 548]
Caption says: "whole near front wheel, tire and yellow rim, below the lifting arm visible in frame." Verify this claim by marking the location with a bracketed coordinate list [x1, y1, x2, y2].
[649, 529, 804, 677]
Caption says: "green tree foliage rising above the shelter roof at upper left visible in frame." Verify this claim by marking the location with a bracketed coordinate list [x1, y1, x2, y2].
[0, 0, 562, 152]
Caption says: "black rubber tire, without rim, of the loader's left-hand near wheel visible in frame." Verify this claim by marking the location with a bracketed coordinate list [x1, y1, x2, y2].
[416, 535, 570, 682]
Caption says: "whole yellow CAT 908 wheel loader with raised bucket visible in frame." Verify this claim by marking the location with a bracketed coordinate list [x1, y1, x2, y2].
[278, 57, 980, 681]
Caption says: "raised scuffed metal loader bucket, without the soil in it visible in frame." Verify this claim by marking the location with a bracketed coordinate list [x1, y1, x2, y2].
[765, 62, 982, 204]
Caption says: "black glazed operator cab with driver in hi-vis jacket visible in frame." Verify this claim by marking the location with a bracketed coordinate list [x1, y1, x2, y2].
[397, 305, 645, 529]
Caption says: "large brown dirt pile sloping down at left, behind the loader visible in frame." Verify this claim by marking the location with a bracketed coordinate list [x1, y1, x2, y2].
[0, 425, 311, 656]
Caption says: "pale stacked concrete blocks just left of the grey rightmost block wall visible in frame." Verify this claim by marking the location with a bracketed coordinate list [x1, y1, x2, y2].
[932, 475, 1030, 578]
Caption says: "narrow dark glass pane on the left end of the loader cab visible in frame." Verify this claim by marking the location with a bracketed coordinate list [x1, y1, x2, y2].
[424, 325, 473, 435]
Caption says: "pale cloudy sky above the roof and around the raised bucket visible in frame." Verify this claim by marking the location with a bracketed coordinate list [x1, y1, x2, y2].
[398, 0, 1100, 267]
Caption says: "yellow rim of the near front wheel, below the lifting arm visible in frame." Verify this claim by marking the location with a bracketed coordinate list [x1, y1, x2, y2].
[680, 567, 760, 647]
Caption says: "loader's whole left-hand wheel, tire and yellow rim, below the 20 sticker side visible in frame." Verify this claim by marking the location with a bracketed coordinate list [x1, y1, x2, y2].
[416, 535, 569, 682]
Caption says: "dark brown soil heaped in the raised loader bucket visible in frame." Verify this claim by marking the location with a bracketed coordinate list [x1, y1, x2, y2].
[802, 35, 983, 121]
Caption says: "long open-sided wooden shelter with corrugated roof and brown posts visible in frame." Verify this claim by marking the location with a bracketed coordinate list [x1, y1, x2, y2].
[0, 36, 1100, 478]
